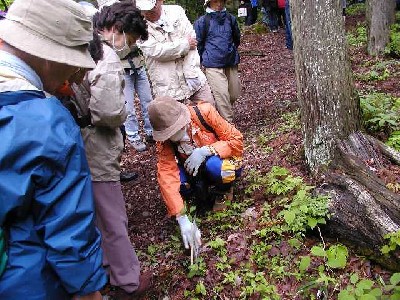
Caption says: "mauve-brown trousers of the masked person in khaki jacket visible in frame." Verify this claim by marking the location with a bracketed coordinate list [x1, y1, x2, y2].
[93, 181, 140, 293]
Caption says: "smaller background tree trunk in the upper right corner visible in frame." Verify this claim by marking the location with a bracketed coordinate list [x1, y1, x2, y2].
[366, 0, 396, 55]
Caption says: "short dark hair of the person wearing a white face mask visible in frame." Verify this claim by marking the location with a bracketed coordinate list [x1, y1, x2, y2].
[93, 0, 149, 40]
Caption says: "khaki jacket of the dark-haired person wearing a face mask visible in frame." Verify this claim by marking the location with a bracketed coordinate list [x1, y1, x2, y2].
[76, 44, 127, 181]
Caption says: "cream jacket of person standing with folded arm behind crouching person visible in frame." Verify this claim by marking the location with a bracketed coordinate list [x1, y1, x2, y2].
[138, 5, 206, 100]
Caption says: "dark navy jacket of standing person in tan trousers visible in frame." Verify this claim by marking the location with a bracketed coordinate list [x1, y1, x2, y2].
[194, 10, 240, 68]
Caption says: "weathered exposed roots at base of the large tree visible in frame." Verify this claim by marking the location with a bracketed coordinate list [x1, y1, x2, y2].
[318, 133, 400, 270]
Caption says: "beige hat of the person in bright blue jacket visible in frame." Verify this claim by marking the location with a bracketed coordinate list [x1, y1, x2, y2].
[0, 0, 96, 69]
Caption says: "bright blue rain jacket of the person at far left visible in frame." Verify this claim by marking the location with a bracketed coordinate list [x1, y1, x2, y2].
[0, 91, 107, 300]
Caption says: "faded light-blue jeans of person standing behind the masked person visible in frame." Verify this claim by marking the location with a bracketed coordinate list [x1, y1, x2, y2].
[124, 67, 153, 142]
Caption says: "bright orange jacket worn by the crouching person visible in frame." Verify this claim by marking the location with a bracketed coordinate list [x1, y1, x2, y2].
[156, 102, 243, 216]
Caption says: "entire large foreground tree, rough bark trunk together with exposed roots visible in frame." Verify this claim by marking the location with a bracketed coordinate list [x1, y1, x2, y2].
[290, 0, 400, 270]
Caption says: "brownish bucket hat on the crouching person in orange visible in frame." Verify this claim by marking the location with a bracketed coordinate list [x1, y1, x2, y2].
[148, 96, 190, 142]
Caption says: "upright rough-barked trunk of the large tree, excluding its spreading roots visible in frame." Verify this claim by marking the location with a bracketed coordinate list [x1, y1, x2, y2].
[290, 0, 360, 172]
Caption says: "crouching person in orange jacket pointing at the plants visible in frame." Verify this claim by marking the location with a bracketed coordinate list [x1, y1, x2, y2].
[149, 96, 243, 248]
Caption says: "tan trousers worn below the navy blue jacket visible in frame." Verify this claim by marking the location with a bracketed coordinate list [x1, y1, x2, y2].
[206, 66, 240, 123]
